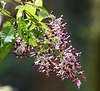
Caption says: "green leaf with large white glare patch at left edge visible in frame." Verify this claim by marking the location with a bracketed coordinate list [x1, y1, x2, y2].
[0, 26, 16, 46]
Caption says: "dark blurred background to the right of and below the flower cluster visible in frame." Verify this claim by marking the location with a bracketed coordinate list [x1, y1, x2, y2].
[0, 0, 100, 91]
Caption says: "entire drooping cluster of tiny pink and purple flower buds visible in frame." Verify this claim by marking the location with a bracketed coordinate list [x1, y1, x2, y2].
[14, 15, 86, 88]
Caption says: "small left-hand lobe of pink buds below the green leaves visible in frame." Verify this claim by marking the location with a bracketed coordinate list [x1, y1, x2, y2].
[13, 36, 40, 58]
